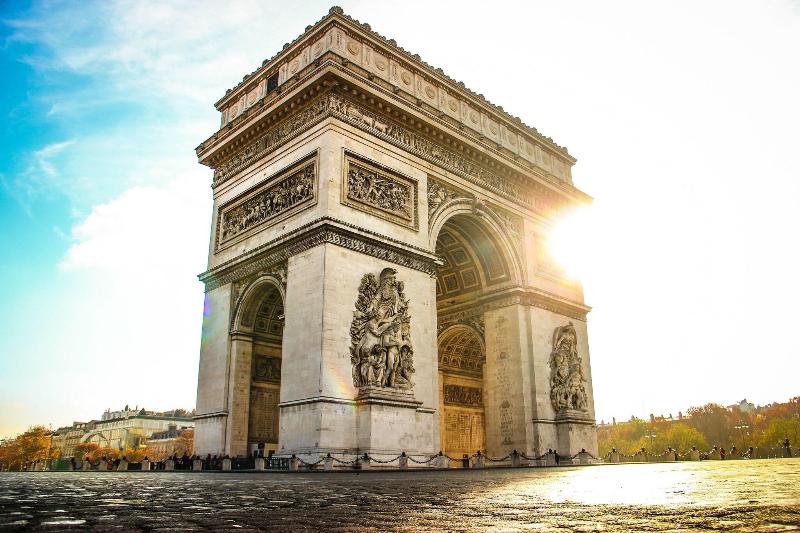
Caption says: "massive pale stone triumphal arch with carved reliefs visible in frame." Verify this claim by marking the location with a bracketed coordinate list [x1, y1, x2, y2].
[195, 8, 597, 459]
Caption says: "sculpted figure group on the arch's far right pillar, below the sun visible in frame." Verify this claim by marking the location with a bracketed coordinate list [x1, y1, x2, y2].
[550, 322, 588, 411]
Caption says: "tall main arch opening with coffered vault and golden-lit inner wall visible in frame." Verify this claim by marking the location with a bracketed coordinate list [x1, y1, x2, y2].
[436, 211, 519, 457]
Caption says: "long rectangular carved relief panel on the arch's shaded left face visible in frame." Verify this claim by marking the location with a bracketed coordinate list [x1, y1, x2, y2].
[217, 153, 317, 246]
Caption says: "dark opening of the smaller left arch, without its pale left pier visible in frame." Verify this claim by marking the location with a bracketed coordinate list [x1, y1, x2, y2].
[233, 276, 284, 456]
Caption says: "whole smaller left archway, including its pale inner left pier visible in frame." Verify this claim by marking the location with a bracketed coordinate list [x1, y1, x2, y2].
[229, 275, 285, 455]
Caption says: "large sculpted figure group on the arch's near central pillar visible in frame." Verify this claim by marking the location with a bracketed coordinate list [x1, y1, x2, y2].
[350, 268, 414, 390]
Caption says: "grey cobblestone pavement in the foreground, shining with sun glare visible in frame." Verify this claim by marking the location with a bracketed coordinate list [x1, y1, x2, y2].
[0, 459, 800, 532]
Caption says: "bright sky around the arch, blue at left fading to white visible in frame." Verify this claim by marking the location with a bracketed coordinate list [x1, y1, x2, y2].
[0, 0, 800, 436]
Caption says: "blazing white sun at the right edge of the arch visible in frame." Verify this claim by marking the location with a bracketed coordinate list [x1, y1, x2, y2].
[544, 208, 591, 280]
